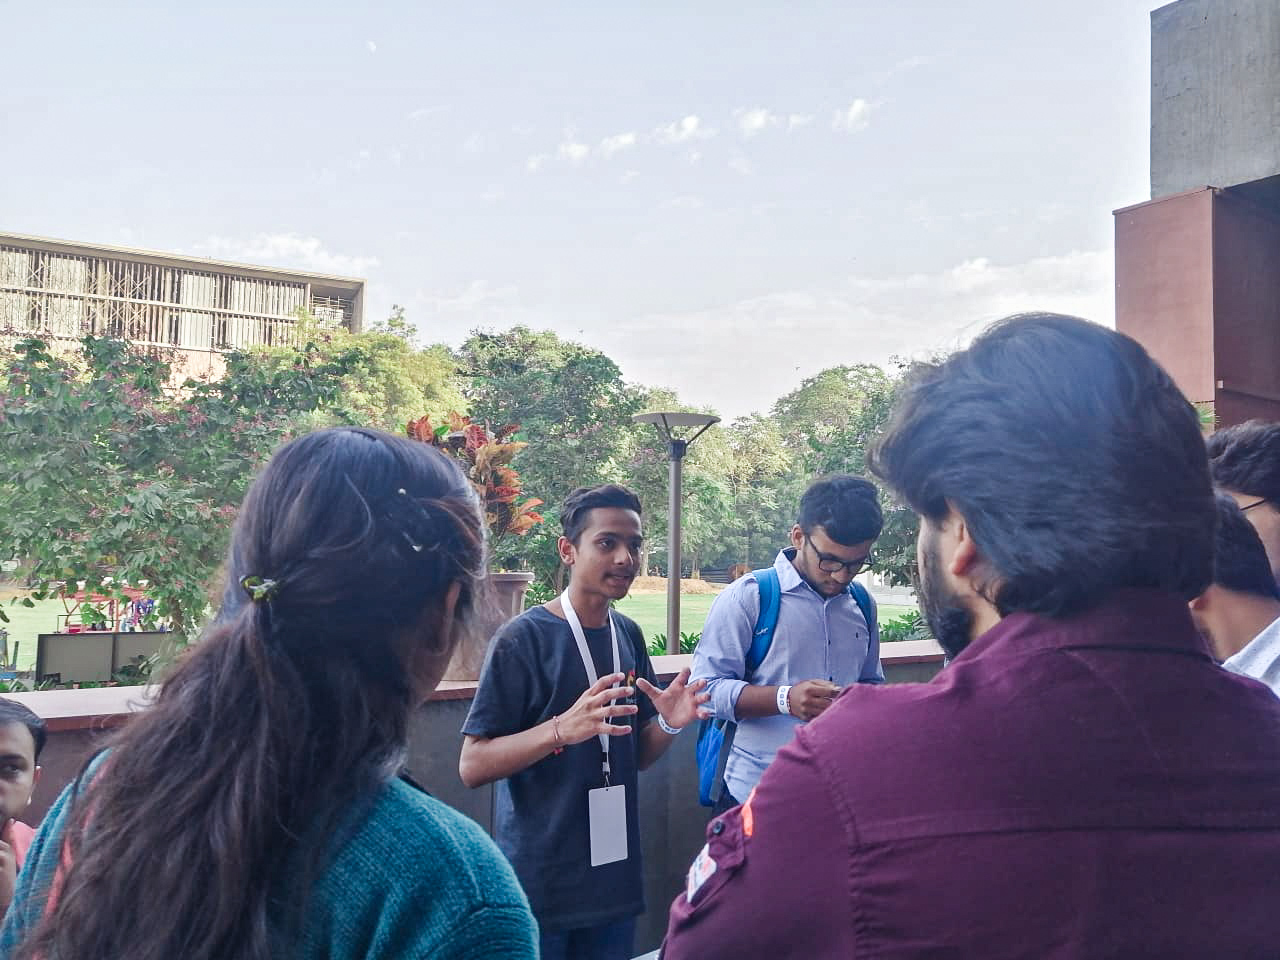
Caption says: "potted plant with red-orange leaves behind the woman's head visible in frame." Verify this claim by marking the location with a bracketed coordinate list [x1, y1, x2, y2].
[407, 412, 543, 680]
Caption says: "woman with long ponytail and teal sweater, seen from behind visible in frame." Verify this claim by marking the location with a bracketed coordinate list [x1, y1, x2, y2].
[0, 428, 536, 960]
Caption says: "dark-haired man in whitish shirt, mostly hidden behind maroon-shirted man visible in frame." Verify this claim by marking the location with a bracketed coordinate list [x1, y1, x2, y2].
[1192, 493, 1280, 695]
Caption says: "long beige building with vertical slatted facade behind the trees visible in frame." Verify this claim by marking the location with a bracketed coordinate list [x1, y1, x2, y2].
[0, 233, 365, 376]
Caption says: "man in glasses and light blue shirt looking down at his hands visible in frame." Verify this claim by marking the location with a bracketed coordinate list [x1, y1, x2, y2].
[692, 475, 884, 812]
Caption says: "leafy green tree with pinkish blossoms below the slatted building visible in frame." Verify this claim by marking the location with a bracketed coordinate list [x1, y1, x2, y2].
[0, 337, 366, 639]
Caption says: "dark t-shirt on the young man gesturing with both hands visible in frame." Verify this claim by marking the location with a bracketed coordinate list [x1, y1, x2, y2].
[462, 607, 657, 931]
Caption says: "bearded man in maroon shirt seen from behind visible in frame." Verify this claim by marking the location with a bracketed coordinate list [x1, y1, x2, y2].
[663, 315, 1280, 960]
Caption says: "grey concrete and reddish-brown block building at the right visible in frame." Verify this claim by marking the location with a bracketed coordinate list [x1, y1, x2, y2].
[1115, 0, 1280, 426]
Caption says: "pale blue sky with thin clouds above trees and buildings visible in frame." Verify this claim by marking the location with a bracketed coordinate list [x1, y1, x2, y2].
[0, 0, 1158, 417]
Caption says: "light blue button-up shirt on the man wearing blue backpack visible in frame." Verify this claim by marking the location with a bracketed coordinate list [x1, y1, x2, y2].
[692, 550, 884, 801]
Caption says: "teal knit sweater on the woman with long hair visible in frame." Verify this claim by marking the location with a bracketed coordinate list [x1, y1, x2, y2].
[0, 780, 538, 960]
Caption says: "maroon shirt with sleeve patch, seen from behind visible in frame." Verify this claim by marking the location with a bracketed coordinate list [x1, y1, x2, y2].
[663, 590, 1280, 960]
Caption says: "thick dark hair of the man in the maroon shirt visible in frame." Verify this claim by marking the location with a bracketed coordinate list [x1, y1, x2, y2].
[870, 314, 1215, 617]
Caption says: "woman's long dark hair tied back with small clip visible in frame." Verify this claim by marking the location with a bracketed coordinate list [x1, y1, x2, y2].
[19, 428, 485, 960]
